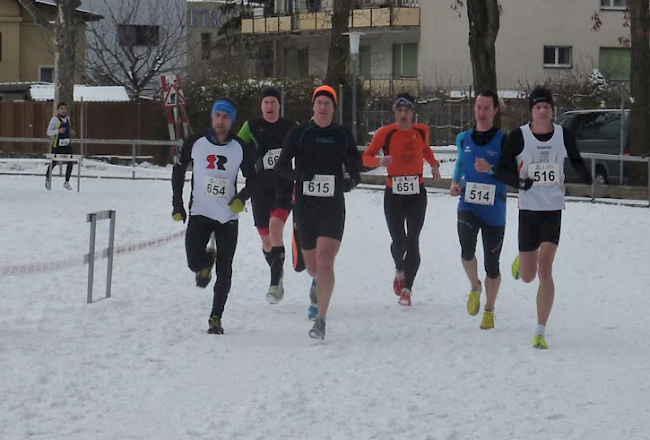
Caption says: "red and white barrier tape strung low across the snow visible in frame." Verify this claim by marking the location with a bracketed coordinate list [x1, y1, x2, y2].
[0, 230, 185, 277]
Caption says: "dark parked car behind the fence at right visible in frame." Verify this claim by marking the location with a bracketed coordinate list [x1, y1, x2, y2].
[557, 110, 630, 185]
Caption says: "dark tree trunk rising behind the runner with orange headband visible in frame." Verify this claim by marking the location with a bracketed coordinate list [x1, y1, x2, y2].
[325, 0, 352, 86]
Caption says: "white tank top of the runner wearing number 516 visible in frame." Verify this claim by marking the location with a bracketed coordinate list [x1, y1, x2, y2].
[517, 124, 567, 211]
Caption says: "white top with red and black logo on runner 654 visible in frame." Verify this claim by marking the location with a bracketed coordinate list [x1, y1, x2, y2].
[190, 137, 244, 223]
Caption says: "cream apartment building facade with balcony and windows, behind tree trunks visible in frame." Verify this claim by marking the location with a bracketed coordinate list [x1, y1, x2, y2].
[241, 0, 630, 93]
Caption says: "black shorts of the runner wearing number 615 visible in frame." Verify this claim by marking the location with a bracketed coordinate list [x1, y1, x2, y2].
[293, 197, 345, 251]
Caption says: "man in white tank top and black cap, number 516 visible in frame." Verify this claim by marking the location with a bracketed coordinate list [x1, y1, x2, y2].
[488, 88, 592, 349]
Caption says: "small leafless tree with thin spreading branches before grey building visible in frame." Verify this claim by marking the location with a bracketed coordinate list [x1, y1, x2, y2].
[86, 0, 187, 100]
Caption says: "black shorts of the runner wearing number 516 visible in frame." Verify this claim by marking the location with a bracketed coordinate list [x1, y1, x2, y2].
[519, 210, 562, 252]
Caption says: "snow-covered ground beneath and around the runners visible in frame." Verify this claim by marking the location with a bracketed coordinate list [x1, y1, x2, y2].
[0, 176, 650, 440]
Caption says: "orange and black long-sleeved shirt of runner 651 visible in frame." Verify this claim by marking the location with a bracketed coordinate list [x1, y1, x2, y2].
[363, 124, 440, 188]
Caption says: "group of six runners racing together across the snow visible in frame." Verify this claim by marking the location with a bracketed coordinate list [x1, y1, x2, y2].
[172, 85, 591, 349]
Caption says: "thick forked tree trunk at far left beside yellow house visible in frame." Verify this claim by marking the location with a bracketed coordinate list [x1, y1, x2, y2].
[18, 0, 83, 107]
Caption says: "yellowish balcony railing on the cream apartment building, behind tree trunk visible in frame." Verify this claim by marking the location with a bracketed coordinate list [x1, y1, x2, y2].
[242, 0, 420, 34]
